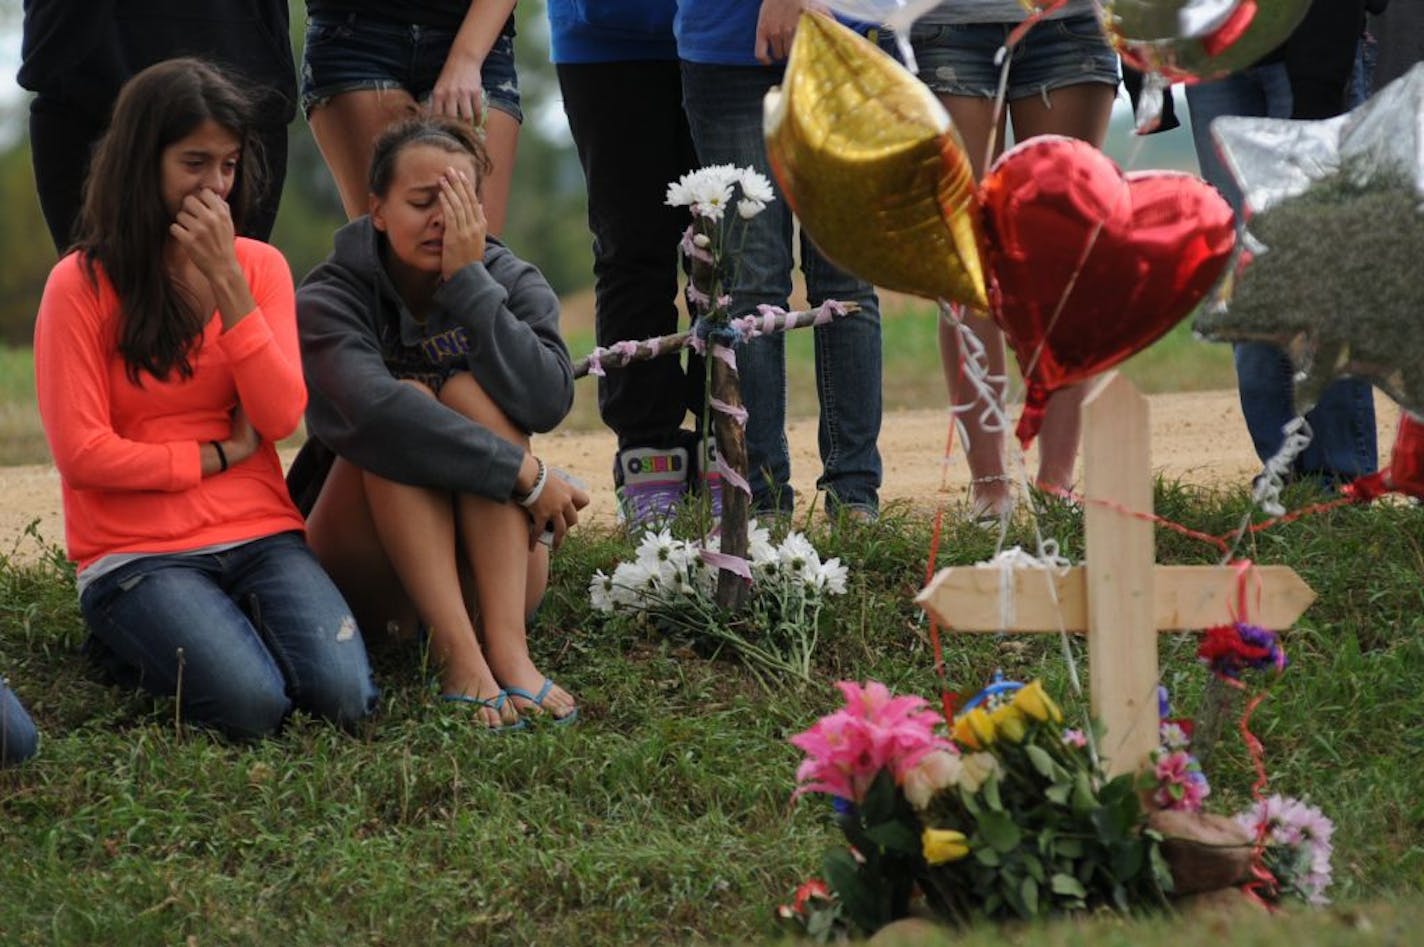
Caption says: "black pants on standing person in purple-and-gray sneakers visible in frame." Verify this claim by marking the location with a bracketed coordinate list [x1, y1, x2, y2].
[558, 60, 702, 449]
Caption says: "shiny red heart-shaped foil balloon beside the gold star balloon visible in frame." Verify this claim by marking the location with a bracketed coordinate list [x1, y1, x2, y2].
[980, 135, 1236, 447]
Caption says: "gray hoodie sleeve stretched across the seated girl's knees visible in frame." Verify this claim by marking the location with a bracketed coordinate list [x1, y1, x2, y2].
[296, 268, 524, 500]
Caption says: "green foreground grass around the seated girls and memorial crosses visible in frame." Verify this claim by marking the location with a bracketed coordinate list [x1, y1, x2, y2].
[0, 486, 1424, 947]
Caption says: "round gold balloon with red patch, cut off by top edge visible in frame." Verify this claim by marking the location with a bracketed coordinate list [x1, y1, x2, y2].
[1104, 0, 1310, 83]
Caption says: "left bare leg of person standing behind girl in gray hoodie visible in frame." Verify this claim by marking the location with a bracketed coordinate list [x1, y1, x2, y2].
[308, 88, 419, 221]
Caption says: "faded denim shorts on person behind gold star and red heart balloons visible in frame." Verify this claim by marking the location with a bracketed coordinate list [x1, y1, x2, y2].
[910, 16, 1119, 101]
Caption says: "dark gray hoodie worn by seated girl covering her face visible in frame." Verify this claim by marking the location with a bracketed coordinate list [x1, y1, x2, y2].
[288, 216, 574, 513]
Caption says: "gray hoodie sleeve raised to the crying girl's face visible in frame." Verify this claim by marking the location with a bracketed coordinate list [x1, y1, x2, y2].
[436, 245, 574, 433]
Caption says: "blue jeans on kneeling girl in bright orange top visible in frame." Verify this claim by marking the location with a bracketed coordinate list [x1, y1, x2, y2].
[80, 533, 377, 739]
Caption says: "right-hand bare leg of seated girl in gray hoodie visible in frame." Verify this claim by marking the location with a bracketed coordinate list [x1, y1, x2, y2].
[440, 372, 575, 716]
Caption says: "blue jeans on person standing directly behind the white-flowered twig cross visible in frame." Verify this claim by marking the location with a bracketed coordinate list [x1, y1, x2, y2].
[682, 63, 881, 513]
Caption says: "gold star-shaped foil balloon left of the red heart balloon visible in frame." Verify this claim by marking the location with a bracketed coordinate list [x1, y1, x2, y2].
[765, 13, 988, 309]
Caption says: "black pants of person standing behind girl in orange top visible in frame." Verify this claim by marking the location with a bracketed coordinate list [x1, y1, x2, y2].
[30, 94, 286, 255]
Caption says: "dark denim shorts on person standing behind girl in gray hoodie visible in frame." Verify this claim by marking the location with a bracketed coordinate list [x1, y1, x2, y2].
[302, 13, 524, 122]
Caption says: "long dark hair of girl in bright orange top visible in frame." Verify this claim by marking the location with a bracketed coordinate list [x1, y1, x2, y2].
[74, 58, 263, 384]
